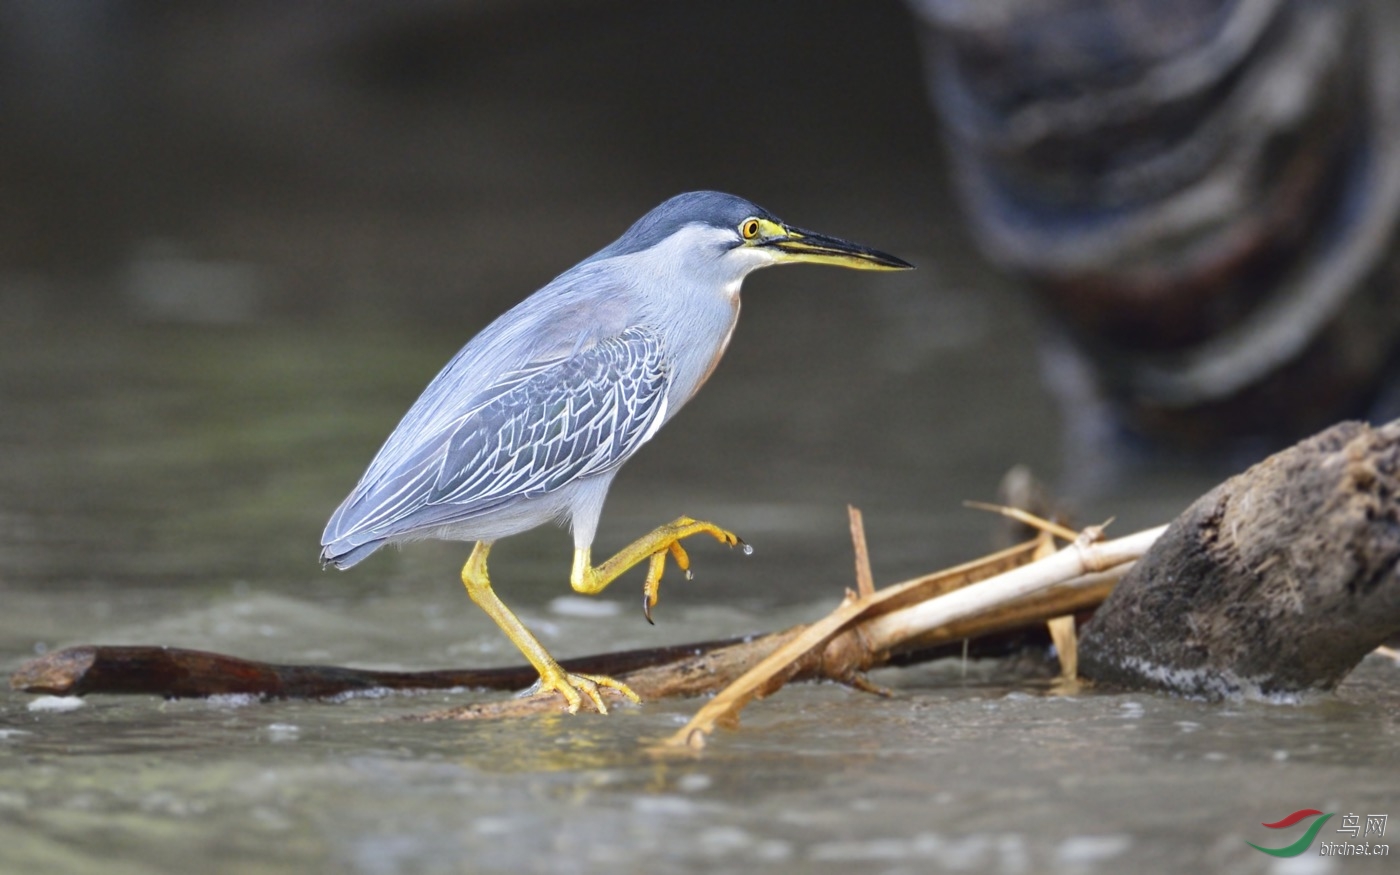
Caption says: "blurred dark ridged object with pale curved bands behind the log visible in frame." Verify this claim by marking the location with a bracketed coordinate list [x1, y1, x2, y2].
[910, 0, 1400, 456]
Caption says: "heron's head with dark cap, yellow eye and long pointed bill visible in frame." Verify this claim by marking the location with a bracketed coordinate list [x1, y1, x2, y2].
[594, 192, 913, 280]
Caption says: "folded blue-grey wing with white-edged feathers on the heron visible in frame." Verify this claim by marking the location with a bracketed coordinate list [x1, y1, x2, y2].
[324, 326, 669, 545]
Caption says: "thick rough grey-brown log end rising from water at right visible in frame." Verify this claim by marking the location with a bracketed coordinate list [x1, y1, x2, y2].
[1079, 420, 1400, 699]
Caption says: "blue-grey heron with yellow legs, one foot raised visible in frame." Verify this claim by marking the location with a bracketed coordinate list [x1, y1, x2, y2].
[321, 192, 911, 713]
